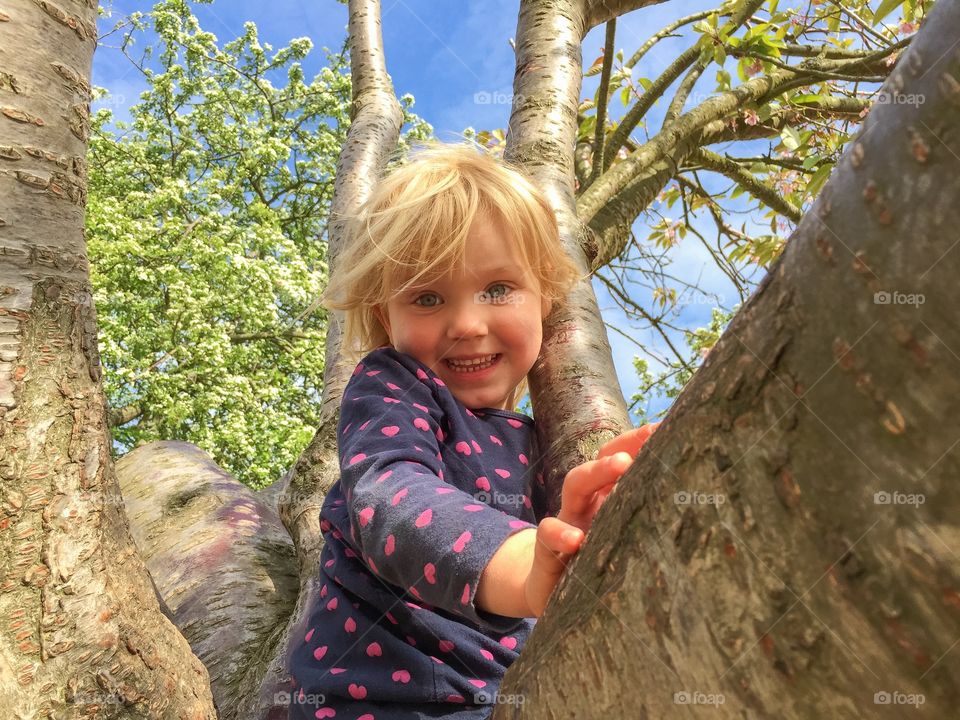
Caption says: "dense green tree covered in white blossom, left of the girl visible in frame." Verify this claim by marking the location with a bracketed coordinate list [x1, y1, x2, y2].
[86, 0, 431, 487]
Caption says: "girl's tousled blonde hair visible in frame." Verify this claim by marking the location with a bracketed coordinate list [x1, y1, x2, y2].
[322, 143, 589, 408]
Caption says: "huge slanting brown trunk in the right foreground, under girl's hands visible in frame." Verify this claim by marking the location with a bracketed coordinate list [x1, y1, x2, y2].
[494, 2, 960, 720]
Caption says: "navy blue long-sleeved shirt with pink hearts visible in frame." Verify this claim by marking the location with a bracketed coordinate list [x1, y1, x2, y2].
[290, 347, 543, 720]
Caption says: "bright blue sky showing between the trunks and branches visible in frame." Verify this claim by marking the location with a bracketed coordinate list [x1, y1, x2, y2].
[93, 0, 762, 424]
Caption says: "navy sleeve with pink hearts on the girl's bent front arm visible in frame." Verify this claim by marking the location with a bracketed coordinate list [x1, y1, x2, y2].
[338, 353, 534, 631]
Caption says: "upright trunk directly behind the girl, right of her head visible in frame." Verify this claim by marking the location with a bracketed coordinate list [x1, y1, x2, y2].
[505, 0, 630, 515]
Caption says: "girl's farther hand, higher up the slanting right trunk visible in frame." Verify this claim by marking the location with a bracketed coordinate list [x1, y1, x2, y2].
[557, 423, 660, 533]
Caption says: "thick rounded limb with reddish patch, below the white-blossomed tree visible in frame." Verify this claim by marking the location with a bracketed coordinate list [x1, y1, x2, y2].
[111, 442, 300, 720]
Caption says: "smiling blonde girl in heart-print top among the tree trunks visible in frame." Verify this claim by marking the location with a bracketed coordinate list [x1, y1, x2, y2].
[290, 145, 650, 720]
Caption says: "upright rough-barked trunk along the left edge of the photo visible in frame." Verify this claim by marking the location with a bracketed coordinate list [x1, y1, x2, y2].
[0, 0, 215, 718]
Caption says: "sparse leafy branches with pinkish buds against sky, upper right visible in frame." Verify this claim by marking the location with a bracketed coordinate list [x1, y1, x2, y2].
[496, 0, 932, 420]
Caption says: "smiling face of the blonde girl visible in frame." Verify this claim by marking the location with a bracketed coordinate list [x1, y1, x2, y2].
[374, 217, 550, 410]
